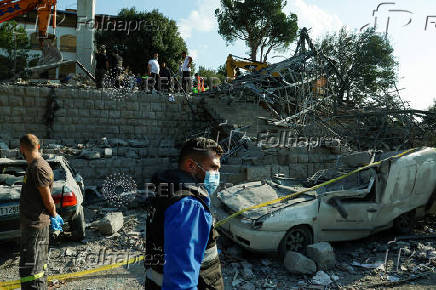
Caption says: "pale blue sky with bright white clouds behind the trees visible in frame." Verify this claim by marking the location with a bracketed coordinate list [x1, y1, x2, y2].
[66, 0, 436, 109]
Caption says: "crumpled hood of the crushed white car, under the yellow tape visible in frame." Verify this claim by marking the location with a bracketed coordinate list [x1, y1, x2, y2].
[217, 181, 316, 219]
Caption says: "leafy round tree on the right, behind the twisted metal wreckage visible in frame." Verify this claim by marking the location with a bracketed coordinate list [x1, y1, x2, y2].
[316, 27, 398, 104]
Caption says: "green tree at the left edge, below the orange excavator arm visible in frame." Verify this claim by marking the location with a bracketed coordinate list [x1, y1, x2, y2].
[0, 21, 30, 79]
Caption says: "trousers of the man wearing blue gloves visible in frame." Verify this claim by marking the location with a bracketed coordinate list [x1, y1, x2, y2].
[19, 225, 49, 290]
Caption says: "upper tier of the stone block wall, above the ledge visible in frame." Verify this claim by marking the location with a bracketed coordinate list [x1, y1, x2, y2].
[0, 86, 206, 143]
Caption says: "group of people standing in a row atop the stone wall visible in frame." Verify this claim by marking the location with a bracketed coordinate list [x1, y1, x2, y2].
[95, 45, 207, 93]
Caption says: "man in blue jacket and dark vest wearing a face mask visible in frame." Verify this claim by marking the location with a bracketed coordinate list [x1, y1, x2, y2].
[144, 138, 224, 290]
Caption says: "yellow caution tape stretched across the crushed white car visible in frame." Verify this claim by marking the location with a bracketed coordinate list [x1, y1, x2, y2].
[215, 148, 416, 227]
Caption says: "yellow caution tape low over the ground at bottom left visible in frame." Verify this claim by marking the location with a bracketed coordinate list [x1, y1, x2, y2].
[0, 256, 144, 290]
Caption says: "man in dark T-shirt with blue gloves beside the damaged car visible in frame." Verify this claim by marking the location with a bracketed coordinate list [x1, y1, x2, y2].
[19, 134, 64, 289]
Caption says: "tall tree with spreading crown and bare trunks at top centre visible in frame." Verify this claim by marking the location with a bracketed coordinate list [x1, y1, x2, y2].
[215, 0, 298, 62]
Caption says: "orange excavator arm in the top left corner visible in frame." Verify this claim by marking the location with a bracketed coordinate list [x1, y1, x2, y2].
[0, 0, 57, 38]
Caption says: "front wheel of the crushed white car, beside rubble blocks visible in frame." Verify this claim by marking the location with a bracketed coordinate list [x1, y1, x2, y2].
[279, 226, 313, 258]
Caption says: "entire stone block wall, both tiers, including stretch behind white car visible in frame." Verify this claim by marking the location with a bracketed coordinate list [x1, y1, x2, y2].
[0, 86, 338, 188]
